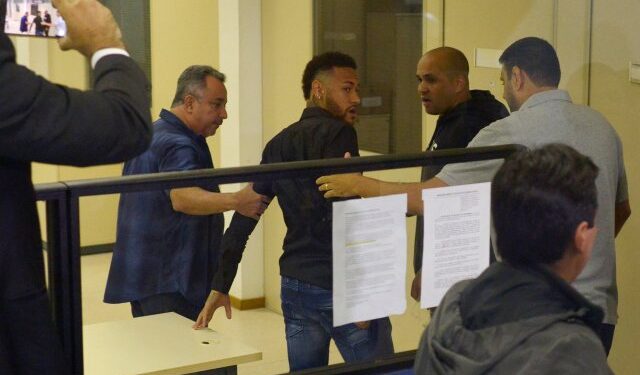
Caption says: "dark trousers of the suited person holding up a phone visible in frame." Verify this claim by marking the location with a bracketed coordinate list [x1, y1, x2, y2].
[0, 289, 71, 374]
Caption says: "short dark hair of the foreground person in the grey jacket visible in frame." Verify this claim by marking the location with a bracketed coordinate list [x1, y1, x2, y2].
[491, 144, 598, 265]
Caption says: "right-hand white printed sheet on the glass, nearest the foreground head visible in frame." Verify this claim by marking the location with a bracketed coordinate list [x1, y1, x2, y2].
[420, 182, 491, 308]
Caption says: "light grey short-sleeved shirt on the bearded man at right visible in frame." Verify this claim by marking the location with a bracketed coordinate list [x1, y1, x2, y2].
[437, 90, 629, 324]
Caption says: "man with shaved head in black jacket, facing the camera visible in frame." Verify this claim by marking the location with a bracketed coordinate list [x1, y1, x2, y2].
[411, 47, 509, 300]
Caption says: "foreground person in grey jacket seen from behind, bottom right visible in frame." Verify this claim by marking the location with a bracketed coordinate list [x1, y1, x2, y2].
[415, 144, 613, 375]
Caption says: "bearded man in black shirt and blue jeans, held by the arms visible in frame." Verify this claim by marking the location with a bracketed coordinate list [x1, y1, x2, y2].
[194, 52, 393, 371]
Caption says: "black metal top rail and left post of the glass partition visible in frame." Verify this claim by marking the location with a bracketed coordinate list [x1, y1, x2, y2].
[36, 145, 523, 374]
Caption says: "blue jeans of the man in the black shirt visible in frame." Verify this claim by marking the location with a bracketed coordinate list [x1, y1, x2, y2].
[280, 276, 394, 371]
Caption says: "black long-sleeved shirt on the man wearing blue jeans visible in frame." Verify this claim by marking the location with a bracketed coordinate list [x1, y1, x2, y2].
[212, 107, 359, 293]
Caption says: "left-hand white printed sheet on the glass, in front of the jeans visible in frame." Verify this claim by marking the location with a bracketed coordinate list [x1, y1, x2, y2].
[333, 194, 407, 327]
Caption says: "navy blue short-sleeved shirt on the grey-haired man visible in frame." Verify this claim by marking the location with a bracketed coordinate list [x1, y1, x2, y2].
[104, 110, 224, 306]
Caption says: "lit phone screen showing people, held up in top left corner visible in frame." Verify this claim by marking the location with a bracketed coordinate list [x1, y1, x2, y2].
[1, 0, 67, 38]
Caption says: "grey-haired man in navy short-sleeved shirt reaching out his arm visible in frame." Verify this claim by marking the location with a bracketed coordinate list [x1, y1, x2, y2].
[104, 65, 266, 320]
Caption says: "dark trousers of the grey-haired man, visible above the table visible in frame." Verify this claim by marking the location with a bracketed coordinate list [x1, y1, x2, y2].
[131, 292, 204, 321]
